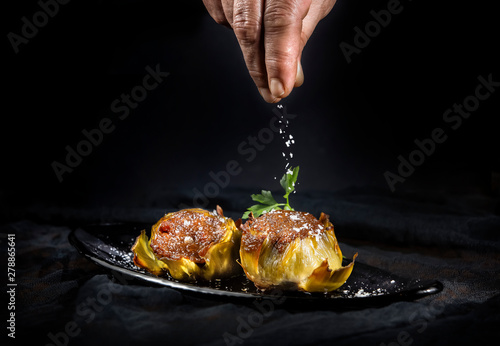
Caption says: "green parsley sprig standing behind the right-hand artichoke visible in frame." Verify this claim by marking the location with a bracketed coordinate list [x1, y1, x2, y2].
[243, 166, 299, 219]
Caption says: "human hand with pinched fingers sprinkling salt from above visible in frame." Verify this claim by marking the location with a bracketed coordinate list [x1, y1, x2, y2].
[203, 0, 336, 103]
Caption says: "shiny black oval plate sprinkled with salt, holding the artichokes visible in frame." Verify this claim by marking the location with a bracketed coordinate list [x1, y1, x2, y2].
[69, 223, 443, 308]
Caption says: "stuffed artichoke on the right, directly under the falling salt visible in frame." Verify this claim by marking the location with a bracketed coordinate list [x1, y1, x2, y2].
[239, 210, 357, 292]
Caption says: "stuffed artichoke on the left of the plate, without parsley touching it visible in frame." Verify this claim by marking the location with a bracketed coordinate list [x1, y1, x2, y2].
[132, 206, 241, 281]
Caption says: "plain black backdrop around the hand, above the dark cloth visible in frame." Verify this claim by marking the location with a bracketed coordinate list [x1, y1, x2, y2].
[0, 0, 500, 219]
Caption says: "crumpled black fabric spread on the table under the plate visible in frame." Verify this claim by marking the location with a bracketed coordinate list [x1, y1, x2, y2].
[2, 189, 500, 346]
